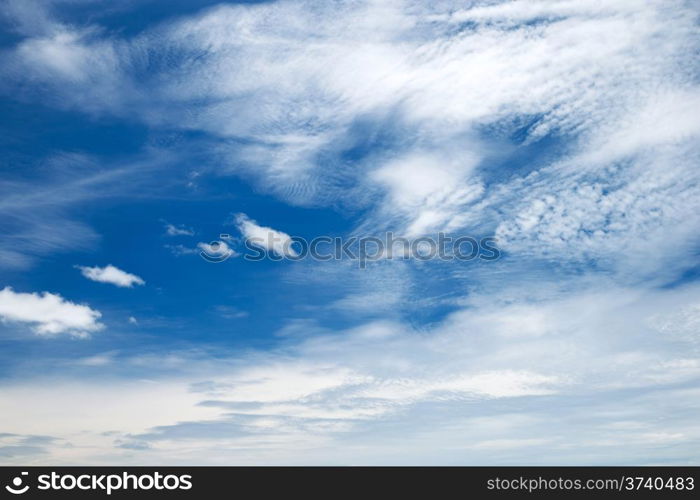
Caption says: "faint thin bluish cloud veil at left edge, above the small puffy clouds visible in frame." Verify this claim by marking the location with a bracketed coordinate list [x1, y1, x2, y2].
[0, 152, 178, 269]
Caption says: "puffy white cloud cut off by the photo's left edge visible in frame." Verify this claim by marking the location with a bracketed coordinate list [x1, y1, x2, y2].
[0, 287, 104, 337]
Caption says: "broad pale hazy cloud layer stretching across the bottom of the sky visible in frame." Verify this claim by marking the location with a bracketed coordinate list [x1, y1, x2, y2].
[0, 283, 700, 465]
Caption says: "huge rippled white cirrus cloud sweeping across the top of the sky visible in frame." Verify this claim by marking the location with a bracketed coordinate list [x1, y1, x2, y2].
[5, 1, 700, 280]
